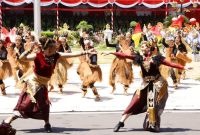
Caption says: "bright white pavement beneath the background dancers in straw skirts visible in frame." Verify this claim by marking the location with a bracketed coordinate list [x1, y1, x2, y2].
[0, 64, 200, 114]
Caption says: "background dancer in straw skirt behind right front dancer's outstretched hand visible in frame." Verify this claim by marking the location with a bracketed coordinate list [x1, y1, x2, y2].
[106, 34, 135, 95]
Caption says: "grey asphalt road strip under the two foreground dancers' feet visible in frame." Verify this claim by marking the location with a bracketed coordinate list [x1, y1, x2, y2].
[0, 111, 200, 135]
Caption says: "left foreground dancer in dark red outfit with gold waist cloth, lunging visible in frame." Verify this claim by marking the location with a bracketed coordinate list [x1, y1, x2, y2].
[2, 37, 94, 132]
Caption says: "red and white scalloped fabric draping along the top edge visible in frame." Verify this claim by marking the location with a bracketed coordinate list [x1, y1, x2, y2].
[1, 0, 200, 8]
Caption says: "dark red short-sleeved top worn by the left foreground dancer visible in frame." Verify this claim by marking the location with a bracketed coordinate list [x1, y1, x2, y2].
[34, 52, 60, 78]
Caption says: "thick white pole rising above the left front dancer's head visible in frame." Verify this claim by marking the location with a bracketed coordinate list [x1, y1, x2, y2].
[34, 0, 41, 41]
